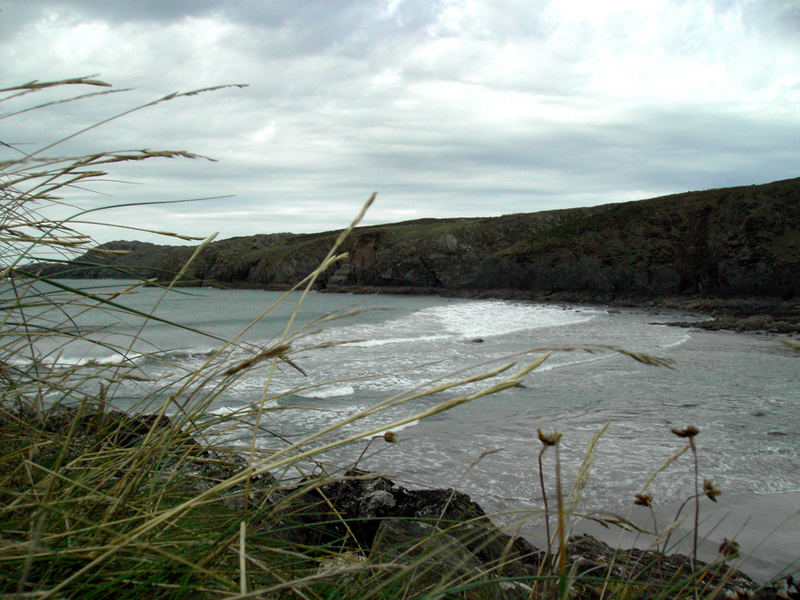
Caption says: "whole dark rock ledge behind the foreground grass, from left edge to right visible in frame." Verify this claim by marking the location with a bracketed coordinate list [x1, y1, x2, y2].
[9, 407, 800, 600]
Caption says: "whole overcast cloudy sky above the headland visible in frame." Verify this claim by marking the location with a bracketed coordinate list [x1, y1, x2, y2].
[0, 0, 800, 243]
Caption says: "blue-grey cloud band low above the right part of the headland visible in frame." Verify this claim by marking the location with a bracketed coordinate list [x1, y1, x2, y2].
[350, 102, 800, 195]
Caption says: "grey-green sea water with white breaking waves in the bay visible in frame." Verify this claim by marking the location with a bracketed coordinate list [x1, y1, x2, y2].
[14, 281, 800, 528]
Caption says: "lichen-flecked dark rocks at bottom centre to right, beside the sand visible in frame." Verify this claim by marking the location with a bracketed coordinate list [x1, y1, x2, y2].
[241, 471, 800, 599]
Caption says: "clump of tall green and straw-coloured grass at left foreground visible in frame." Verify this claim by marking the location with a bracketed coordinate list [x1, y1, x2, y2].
[0, 79, 546, 598]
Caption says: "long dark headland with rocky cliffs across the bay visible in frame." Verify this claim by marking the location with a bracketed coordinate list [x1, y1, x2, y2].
[36, 179, 800, 300]
